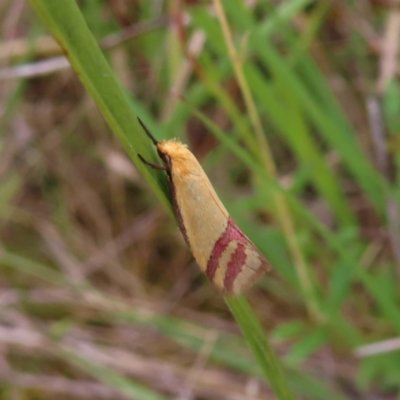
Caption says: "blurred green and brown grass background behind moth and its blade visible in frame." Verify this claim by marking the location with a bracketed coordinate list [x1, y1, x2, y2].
[0, 0, 400, 400]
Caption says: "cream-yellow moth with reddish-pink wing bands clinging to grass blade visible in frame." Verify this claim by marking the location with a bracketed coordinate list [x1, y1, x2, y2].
[138, 119, 270, 296]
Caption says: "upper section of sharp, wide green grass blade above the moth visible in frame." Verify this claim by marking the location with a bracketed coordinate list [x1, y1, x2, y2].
[27, 0, 172, 210]
